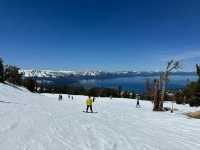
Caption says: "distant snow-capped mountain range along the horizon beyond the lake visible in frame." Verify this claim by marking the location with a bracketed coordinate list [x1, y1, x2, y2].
[20, 69, 194, 78]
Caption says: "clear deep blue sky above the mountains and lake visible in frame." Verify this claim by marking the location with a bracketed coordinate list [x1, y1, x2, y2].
[0, 0, 200, 71]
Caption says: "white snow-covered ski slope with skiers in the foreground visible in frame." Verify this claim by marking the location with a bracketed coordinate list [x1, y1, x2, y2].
[0, 84, 200, 150]
